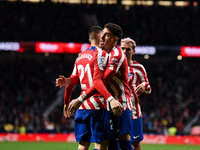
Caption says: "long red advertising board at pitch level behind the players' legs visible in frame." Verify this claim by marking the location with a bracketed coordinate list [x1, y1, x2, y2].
[0, 133, 200, 145]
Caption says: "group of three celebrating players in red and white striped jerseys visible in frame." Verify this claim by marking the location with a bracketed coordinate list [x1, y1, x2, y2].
[56, 23, 151, 150]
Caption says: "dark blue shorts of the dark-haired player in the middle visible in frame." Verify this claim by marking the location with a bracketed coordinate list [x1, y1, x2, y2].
[111, 109, 132, 138]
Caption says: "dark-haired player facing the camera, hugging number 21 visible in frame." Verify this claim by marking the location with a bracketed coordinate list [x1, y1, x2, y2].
[68, 23, 133, 150]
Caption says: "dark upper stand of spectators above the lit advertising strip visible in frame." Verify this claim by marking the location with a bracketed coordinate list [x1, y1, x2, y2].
[0, 1, 200, 46]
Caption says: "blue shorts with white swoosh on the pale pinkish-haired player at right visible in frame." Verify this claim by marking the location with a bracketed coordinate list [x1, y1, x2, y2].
[131, 117, 143, 142]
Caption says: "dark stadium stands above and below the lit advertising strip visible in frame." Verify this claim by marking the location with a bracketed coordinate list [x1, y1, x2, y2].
[0, 1, 200, 145]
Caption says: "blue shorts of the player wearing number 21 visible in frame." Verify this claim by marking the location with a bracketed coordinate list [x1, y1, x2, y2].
[74, 109, 113, 143]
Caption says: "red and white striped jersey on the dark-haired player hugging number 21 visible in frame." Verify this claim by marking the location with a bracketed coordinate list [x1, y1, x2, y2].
[93, 47, 132, 110]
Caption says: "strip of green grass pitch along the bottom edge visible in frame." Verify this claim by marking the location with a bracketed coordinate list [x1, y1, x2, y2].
[0, 142, 200, 150]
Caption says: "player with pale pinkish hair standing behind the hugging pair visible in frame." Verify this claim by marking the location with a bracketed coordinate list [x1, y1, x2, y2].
[120, 38, 151, 150]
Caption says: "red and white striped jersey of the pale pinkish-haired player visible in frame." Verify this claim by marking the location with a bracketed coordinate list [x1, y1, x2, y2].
[128, 61, 151, 119]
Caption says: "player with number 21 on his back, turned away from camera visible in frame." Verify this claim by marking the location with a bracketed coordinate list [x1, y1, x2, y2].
[56, 26, 112, 150]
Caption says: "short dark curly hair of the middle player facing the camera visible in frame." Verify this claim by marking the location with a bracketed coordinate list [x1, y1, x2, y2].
[104, 23, 123, 39]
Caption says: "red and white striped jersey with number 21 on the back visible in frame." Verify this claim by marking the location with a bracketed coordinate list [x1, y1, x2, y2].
[72, 46, 106, 109]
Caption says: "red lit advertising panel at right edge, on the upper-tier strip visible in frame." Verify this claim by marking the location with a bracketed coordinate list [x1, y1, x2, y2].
[180, 46, 200, 57]
